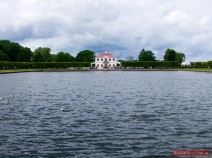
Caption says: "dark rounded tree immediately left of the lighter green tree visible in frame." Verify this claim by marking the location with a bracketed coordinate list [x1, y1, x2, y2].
[16, 48, 32, 62]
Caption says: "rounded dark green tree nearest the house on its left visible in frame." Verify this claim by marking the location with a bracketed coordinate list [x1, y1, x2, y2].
[76, 50, 95, 62]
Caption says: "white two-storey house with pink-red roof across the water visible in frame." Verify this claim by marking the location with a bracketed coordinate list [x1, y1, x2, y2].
[91, 51, 120, 69]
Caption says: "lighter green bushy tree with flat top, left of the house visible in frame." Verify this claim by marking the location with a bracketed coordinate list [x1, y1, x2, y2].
[33, 47, 52, 62]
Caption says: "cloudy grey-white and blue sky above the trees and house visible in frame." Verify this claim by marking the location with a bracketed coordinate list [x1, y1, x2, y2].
[0, 0, 212, 61]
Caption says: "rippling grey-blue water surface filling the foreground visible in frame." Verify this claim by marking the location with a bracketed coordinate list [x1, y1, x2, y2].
[0, 72, 212, 157]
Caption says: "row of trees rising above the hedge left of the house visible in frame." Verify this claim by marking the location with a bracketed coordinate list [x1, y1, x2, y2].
[0, 40, 95, 62]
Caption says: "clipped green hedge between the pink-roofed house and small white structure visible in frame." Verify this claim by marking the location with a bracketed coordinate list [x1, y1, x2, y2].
[121, 61, 179, 68]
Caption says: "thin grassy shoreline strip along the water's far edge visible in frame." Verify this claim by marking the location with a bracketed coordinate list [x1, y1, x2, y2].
[0, 68, 212, 74]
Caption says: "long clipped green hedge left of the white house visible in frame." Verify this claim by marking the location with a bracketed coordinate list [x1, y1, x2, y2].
[0, 62, 91, 69]
